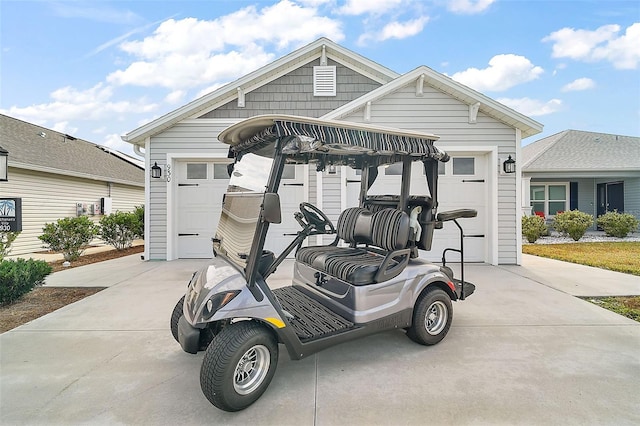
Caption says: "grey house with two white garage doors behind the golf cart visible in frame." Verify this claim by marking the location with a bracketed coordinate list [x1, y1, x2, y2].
[123, 38, 542, 264]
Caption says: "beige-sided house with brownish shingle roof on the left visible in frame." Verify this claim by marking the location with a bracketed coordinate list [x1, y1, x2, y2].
[0, 114, 145, 256]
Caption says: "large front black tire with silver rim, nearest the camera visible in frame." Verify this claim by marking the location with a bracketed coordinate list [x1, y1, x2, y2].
[200, 321, 278, 411]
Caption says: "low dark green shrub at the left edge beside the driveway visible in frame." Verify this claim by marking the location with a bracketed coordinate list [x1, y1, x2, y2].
[0, 259, 51, 305]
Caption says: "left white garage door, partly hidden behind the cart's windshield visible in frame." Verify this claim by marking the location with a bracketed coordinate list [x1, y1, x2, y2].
[177, 160, 306, 259]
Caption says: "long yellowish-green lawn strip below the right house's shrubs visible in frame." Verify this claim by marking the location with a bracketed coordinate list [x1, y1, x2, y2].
[522, 242, 640, 276]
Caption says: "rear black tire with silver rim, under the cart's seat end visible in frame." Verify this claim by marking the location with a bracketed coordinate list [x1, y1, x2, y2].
[407, 288, 453, 346]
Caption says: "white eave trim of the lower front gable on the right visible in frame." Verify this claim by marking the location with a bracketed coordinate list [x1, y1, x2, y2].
[323, 65, 543, 139]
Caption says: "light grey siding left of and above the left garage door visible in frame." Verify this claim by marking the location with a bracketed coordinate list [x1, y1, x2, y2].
[146, 119, 239, 260]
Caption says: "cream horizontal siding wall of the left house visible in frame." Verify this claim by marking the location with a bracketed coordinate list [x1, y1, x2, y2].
[1, 168, 144, 257]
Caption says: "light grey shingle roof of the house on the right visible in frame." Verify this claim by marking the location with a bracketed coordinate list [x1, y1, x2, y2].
[522, 130, 640, 172]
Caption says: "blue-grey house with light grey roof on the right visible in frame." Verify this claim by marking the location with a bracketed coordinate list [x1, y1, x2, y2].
[522, 130, 640, 228]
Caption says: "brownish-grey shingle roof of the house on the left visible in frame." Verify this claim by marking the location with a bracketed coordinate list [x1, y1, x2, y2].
[0, 114, 144, 186]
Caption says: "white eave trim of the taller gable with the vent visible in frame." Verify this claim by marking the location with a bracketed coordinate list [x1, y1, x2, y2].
[122, 37, 399, 145]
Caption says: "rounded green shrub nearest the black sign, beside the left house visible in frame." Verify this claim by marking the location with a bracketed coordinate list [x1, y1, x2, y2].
[38, 216, 98, 261]
